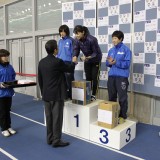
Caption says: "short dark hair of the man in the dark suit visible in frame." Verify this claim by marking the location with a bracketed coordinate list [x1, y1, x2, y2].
[45, 40, 57, 54]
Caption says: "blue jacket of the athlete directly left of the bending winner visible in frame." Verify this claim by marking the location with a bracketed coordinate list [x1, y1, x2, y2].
[57, 36, 74, 62]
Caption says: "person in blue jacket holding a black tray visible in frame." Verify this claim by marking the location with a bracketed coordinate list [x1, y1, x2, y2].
[0, 49, 16, 137]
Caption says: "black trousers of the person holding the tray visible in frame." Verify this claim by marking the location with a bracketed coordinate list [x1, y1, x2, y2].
[0, 97, 12, 131]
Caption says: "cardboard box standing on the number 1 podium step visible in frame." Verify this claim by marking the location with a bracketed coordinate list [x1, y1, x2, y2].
[72, 81, 91, 105]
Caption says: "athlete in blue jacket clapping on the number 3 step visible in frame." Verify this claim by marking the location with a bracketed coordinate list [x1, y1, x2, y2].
[106, 31, 132, 123]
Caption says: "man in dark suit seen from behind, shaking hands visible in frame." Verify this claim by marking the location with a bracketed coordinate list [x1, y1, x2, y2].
[38, 40, 75, 147]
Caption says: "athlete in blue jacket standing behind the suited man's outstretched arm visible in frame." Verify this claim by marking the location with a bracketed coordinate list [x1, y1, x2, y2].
[57, 25, 74, 99]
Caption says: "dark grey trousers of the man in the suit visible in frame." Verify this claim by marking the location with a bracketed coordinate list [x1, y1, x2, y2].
[44, 100, 64, 144]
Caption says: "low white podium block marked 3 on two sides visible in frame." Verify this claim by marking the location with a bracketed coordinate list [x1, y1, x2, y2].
[90, 120, 136, 150]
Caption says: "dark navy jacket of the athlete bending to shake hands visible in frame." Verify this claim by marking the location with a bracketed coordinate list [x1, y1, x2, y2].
[73, 35, 102, 63]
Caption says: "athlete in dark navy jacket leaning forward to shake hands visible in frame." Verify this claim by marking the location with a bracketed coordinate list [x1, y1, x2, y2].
[73, 25, 102, 101]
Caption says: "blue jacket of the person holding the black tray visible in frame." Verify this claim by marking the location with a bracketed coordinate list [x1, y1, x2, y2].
[0, 64, 16, 98]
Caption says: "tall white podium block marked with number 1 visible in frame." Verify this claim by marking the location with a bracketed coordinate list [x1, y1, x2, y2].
[63, 100, 102, 140]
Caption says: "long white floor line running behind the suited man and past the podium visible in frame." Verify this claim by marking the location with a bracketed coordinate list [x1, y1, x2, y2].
[11, 112, 144, 160]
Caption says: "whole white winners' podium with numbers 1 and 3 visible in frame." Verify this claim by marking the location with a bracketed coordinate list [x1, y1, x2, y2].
[63, 100, 136, 150]
